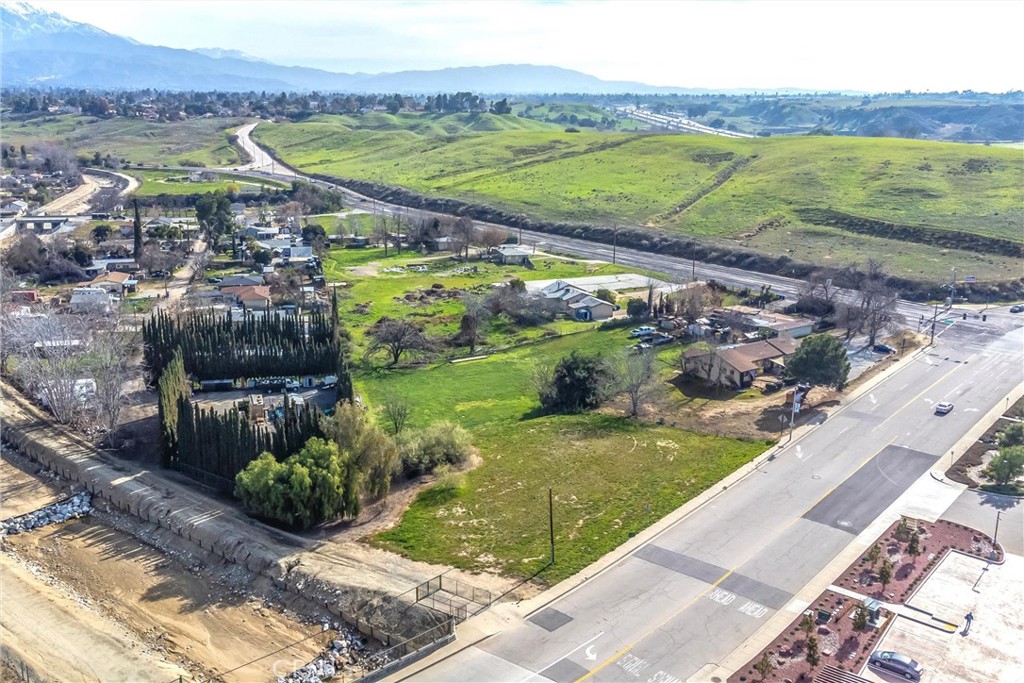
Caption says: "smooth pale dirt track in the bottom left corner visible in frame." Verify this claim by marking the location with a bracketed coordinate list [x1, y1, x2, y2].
[0, 553, 188, 681]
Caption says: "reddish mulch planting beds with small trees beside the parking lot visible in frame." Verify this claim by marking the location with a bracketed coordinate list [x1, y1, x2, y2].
[729, 517, 1004, 683]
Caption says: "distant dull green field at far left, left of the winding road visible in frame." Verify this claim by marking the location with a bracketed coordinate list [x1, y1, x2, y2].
[3, 115, 246, 167]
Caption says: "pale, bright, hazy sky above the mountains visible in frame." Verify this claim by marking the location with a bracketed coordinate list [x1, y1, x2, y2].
[30, 0, 1024, 92]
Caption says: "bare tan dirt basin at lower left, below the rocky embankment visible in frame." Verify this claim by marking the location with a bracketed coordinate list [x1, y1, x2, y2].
[0, 452, 330, 681]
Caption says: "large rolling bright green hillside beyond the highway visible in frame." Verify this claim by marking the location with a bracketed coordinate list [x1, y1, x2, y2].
[256, 115, 1024, 280]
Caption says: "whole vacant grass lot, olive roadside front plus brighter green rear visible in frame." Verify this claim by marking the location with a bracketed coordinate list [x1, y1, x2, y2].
[356, 323, 768, 583]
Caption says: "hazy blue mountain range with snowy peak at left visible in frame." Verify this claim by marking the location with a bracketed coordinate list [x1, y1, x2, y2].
[0, 2, 708, 94]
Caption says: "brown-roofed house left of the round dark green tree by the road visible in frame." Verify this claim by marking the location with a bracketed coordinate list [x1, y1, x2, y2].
[683, 337, 800, 389]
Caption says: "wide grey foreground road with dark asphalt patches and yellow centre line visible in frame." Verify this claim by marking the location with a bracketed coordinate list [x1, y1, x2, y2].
[415, 323, 1024, 683]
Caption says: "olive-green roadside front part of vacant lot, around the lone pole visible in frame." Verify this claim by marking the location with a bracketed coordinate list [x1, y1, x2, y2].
[373, 414, 768, 584]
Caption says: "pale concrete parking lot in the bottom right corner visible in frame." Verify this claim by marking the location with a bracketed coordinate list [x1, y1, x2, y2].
[860, 553, 1024, 683]
